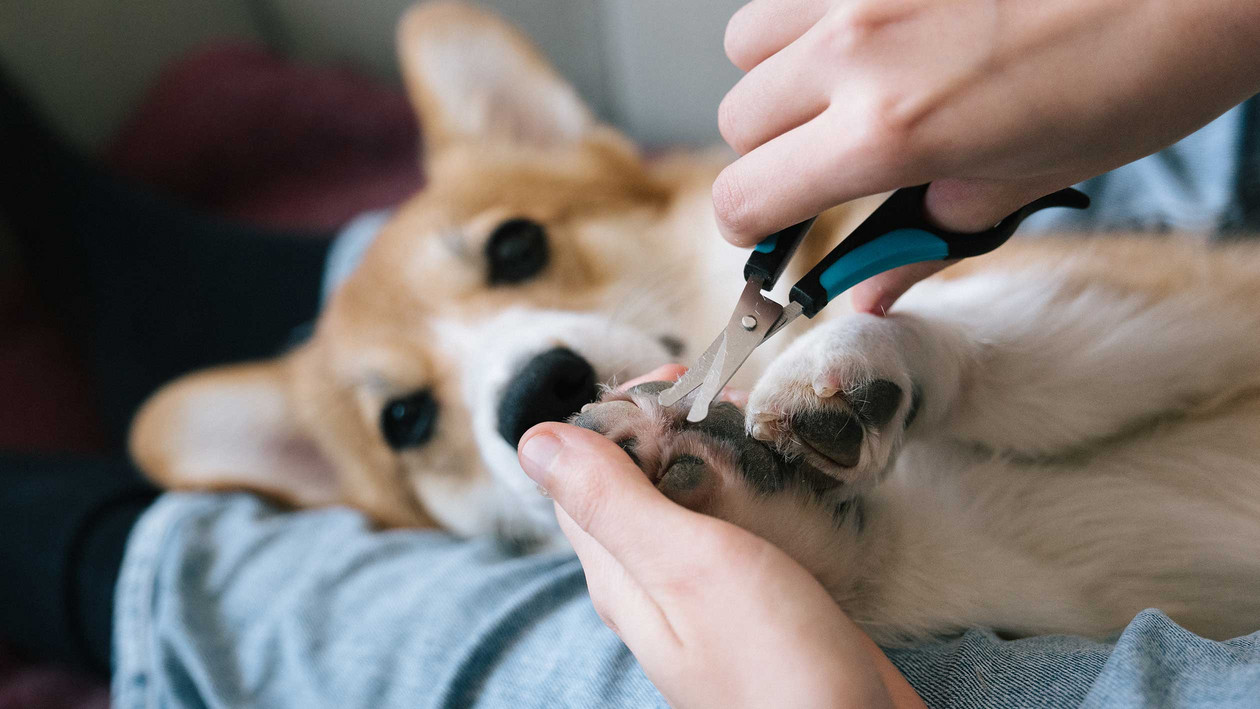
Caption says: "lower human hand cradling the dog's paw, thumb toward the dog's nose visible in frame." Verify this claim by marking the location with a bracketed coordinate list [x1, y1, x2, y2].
[520, 366, 922, 708]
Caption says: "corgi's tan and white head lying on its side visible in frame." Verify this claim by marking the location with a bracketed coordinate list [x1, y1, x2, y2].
[132, 4, 738, 544]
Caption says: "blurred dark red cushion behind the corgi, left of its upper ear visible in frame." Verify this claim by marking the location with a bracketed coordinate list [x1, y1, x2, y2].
[106, 44, 421, 229]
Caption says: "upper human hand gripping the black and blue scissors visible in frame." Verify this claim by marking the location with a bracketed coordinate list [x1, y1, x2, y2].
[713, 0, 1260, 314]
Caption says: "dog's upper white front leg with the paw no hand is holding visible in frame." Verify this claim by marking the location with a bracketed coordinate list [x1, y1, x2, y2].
[748, 271, 1260, 468]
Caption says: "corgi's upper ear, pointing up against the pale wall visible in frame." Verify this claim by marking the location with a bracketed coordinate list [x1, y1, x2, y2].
[398, 1, 595, 152]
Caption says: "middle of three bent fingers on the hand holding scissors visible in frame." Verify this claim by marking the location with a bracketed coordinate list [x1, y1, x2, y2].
[717, 31, 829, 155]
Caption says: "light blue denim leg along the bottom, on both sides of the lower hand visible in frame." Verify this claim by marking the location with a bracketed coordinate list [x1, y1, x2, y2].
[113, 494, 1260, 709]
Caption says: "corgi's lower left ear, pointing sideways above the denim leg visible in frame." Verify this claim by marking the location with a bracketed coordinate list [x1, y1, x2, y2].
[131, 359, 340, 506]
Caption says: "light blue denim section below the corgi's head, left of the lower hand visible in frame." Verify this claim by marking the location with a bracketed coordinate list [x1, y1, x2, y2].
[112, 494, 667, 709]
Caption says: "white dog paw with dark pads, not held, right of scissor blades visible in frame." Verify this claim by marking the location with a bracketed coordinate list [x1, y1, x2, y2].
[747, 316, 917, 489]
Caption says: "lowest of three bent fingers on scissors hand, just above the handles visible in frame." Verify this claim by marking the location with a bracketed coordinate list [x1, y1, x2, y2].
[713, 110, 927, 247]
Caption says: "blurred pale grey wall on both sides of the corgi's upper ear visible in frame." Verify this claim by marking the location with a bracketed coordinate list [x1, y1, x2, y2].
[0, 0, 745, 146]
